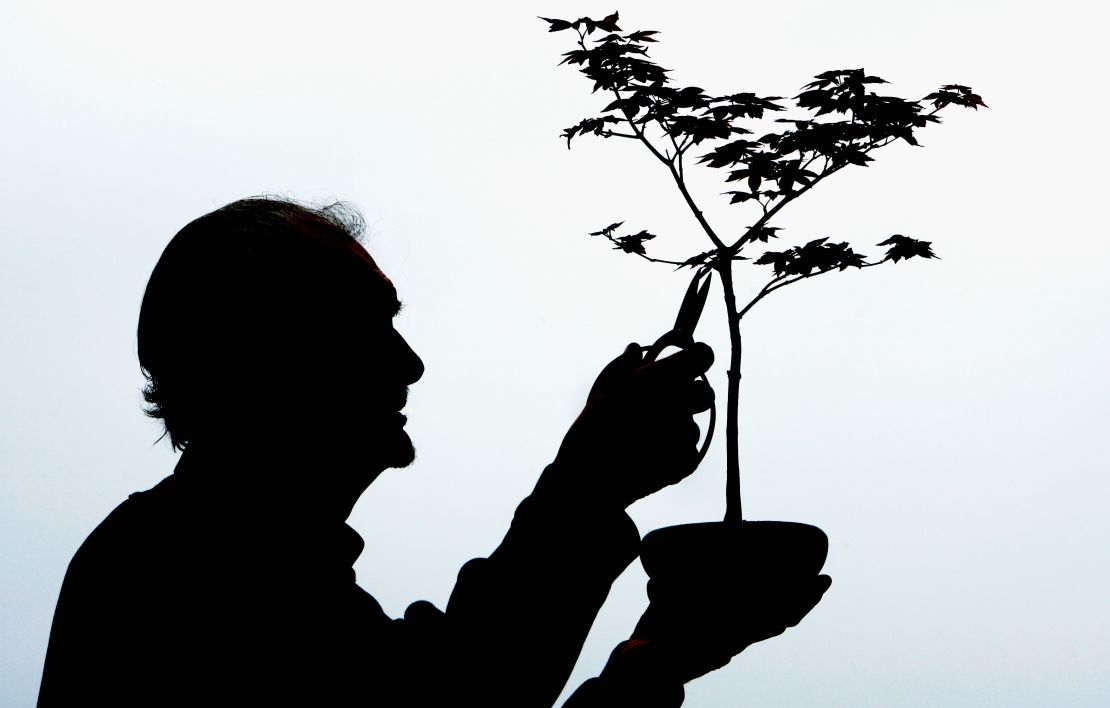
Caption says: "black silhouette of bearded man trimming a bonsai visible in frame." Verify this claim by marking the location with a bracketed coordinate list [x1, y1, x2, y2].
[39, 199, 827, 708]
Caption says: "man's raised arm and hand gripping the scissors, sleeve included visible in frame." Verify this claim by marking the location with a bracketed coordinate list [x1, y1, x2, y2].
[390, 345, 713, 708]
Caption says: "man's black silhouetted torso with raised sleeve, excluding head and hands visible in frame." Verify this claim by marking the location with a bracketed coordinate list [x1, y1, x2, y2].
[39, 455, 639, 708]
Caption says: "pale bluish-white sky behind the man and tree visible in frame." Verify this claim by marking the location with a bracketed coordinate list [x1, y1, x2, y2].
[0, 0, 1110, 707]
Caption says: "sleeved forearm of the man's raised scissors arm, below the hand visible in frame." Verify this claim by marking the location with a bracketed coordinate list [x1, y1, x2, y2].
[437, 474, 639, 707]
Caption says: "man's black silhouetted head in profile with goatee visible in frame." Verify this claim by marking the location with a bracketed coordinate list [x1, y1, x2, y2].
[139, 199, 423, 469]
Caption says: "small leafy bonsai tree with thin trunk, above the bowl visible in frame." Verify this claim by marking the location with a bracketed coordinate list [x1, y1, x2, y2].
[539, 12, 986, 523]
